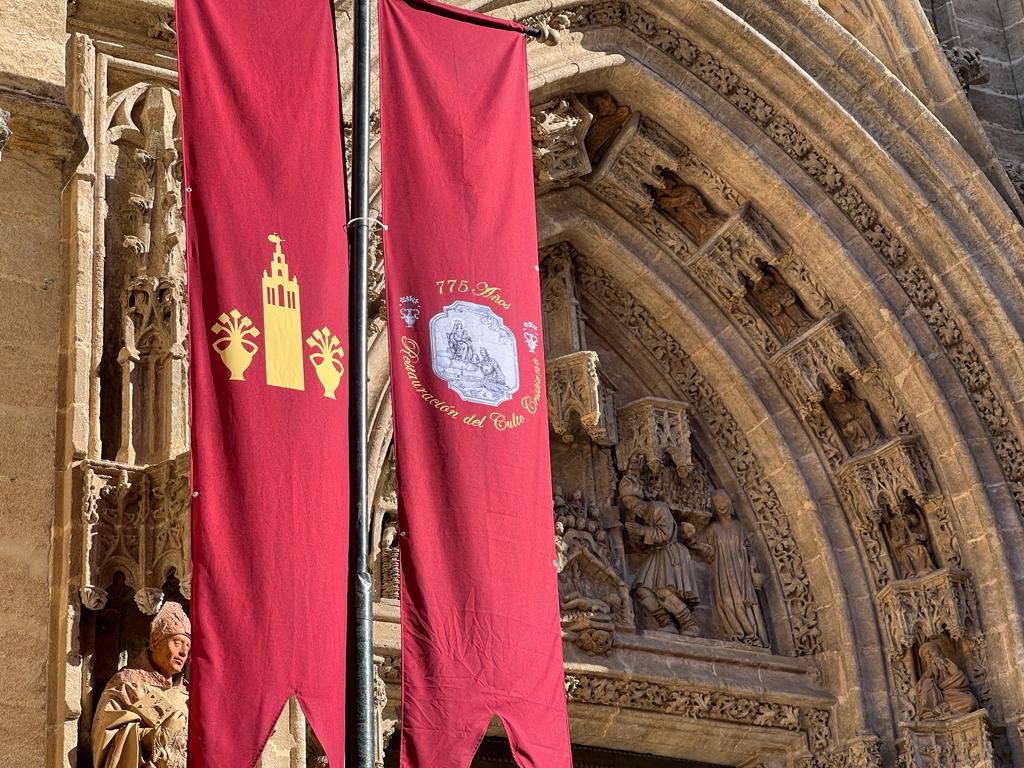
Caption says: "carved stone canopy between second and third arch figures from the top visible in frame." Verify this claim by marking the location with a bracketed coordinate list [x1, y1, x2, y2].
[684, 204, 785, 307]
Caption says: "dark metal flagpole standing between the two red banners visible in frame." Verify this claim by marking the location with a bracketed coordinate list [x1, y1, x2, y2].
[345, 0, 376, 757]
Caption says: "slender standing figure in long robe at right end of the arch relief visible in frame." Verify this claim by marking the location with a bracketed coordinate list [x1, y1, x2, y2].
[705, 488, 768, 647]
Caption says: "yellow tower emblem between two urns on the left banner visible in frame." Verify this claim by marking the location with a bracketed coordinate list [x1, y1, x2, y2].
[263, 233, 305, 389]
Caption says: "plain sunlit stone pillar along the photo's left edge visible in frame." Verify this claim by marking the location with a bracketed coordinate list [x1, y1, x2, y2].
[0, 0, 83, 768]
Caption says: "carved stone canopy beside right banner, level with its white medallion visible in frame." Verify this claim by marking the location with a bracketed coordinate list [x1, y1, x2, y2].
[547, 350, 618, 445]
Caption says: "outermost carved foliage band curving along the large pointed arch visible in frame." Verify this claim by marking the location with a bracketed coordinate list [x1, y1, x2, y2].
[561, 0, 1024, 515]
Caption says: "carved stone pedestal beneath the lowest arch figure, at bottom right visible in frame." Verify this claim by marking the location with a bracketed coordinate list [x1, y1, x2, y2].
[897, 710, 996, 768]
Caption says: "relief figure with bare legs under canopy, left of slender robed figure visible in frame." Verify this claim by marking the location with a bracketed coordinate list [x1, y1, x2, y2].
[618, 474, 711, 635]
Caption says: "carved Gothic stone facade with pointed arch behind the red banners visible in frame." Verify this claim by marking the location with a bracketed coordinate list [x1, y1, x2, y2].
[0, 0, 1024, 768]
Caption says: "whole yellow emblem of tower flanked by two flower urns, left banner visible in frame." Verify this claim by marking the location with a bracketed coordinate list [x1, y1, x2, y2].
[210, 232, 345, 400]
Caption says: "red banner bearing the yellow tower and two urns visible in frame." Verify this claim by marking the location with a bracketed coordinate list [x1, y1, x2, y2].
[177, 0, 348, 768]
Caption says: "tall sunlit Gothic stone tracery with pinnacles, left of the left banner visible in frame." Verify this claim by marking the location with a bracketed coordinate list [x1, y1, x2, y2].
[101, 82, 187, 464]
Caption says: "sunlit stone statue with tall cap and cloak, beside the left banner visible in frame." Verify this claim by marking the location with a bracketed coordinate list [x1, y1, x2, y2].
[92, 602, 191, 768]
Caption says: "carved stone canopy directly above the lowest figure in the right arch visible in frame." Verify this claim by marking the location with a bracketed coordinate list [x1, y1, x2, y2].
[879, 568, 981, 656]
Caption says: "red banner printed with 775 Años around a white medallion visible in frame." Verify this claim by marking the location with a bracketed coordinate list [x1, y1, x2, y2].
[379, 0, 571, 768]
